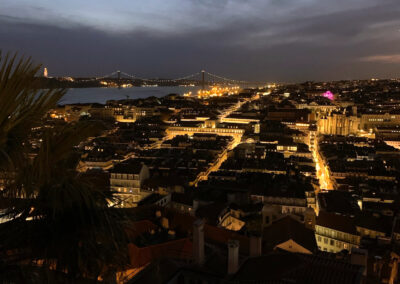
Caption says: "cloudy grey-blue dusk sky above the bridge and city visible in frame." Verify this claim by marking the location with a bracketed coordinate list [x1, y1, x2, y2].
[0, 0, 400, 82]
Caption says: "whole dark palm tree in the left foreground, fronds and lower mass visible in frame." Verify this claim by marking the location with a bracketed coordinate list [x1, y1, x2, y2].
[0, 54, 127, 283]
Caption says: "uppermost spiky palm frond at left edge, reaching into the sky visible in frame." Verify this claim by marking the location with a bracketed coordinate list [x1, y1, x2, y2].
[0, 53, 65, 168]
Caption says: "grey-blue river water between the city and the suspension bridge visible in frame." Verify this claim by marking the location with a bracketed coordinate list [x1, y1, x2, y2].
[60, 86, 200, 105]
